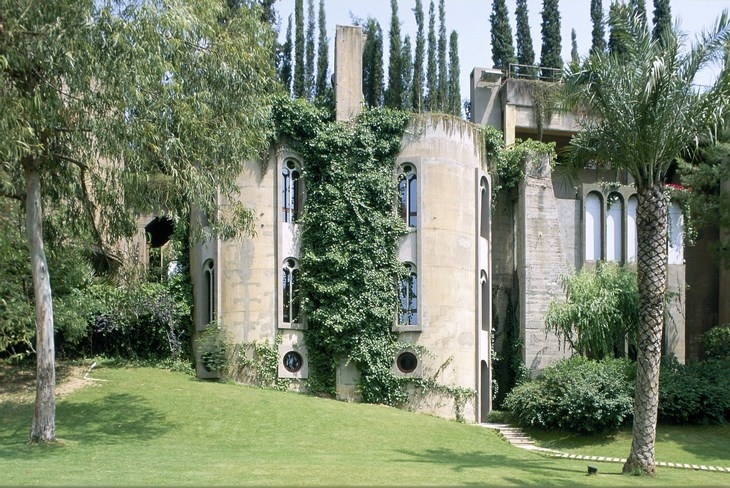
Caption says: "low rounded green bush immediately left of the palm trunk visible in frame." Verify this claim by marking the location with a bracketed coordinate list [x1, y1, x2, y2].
[505, 356, 635, 435]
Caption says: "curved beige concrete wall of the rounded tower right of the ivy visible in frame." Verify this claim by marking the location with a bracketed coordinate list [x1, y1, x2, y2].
[398, 116, 491, 422]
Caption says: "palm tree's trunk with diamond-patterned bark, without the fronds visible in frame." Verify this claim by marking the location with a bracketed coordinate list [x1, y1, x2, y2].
[623, 183, 667, 475]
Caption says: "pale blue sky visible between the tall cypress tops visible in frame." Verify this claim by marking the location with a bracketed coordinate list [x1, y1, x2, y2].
[275, 0, 730, 99]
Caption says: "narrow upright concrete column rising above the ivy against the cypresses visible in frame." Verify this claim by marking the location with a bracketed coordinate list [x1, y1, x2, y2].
[335, 25, 365, 122]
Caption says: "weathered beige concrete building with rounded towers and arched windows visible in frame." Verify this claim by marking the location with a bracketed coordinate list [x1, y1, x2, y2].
[183, 26, 700, 422]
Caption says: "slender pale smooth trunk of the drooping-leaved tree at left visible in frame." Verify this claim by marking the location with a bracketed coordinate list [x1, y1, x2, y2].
[25, 162, 56, 442]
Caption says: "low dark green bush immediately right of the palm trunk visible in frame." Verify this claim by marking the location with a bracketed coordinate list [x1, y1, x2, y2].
[659, 356, 730, 424]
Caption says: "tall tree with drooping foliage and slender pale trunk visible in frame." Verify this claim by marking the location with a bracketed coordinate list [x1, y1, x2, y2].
[0, 0, 276, 442]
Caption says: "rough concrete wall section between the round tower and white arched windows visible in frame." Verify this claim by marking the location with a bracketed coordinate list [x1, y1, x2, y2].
[516, 156, 574, 372]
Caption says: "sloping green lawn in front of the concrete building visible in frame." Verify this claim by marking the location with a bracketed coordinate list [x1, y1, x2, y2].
[0, 367, 730, 486]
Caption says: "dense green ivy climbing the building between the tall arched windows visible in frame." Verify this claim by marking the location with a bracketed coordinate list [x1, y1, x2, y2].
[273, 97, 410, 405]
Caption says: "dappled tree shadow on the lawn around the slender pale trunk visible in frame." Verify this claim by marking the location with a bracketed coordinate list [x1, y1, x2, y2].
[0, 393, 176, 459]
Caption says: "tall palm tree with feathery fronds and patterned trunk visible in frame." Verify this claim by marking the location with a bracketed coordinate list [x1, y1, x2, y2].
[564, 9, 730, 475]
